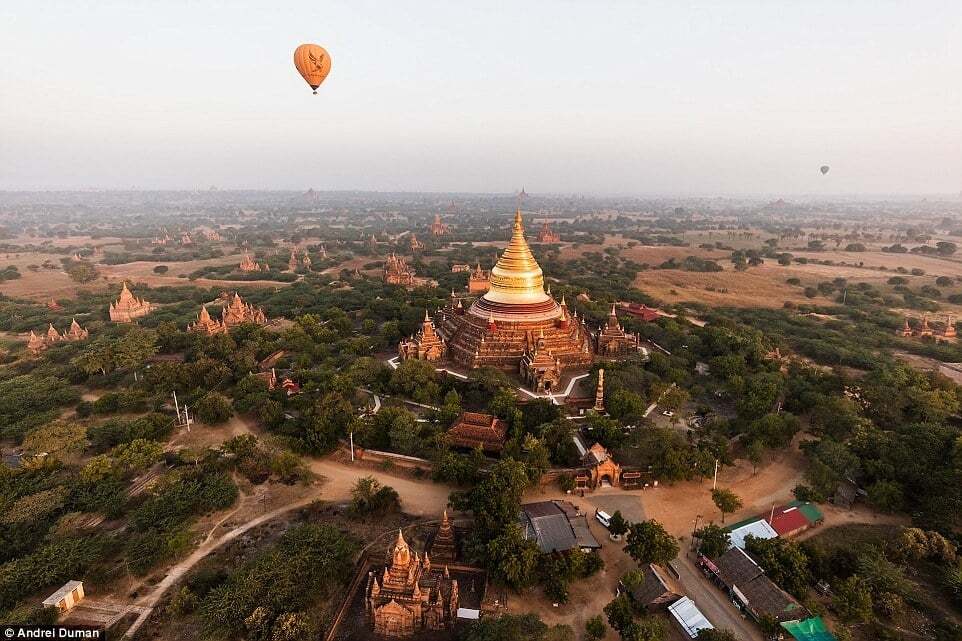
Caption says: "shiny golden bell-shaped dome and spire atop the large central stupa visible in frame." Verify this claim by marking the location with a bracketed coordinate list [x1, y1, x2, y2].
[483, 209, 551, 304]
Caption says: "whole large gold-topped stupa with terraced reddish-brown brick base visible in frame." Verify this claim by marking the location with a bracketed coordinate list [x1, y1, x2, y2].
[437, 210, 593, 392]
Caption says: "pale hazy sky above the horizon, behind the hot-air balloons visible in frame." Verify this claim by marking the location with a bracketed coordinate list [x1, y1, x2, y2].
[0, 0, 962, 195]
